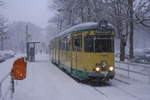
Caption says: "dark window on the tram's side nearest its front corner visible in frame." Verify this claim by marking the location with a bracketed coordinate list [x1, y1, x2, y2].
[73, 36, 82, 51]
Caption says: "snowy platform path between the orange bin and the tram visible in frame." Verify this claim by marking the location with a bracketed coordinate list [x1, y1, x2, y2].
[14, 54, 107, 100]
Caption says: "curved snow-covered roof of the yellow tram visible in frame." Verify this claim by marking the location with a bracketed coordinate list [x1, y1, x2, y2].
[49, 22, 113, 38]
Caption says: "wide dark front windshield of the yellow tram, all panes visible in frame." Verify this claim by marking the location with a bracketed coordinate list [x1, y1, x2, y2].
[84, 36, 114, 52]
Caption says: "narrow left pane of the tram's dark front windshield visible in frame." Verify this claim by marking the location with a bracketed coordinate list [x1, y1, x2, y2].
[84, 36, 94, 52]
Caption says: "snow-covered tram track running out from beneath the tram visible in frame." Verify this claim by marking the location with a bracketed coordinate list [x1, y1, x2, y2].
[53, 61, 142, 100]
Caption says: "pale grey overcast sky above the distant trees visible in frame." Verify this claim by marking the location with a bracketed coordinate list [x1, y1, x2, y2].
[2, 0, 54, 28]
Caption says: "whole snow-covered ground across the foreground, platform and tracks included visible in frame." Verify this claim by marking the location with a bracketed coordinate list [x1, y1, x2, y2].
[0, 55, 150, 100]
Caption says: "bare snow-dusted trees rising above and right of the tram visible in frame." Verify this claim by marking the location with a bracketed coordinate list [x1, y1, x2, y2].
[50, 0, 150, 61]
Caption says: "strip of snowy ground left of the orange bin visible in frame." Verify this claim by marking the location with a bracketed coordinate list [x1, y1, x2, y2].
[0, 54, 24, 100]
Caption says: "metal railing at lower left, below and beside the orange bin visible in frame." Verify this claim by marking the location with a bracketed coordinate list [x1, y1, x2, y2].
[0, 73, 14, 100]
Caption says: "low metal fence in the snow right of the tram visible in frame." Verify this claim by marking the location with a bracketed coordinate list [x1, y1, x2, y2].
[115, 61, 150, 83]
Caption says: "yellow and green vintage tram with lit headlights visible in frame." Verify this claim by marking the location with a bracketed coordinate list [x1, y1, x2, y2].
[49, 20, 115, 80]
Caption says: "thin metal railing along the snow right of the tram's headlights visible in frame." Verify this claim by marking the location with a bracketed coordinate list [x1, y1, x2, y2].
[115, 61, 150, 83]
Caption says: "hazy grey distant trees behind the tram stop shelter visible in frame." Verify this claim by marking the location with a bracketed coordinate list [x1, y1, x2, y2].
[5, 22, 42, 52]
